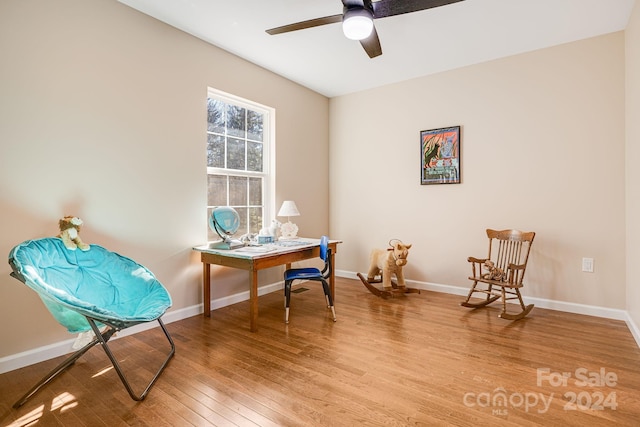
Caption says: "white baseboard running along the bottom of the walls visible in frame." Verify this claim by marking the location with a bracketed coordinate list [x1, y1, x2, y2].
[0, 270, 640, 374]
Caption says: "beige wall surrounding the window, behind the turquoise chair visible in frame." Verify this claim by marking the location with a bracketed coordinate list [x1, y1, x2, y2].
[0, 0, 329, 358]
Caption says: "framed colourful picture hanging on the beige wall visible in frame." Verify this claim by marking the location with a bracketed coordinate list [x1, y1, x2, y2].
[420, 126, 461, 185]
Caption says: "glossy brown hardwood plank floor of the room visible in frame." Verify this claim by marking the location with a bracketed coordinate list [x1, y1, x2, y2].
[0, 278, 640, 427]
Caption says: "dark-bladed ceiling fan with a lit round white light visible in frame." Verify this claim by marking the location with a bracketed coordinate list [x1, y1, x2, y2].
[267, 0, 464, 58]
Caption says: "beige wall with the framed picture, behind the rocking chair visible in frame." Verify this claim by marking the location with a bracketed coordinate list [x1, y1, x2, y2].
[330, 33, 626, 309]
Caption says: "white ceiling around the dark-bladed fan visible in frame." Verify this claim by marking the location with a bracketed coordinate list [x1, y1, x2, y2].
[119, 0, 635, 97]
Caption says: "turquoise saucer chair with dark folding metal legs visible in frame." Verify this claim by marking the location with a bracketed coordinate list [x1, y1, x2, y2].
[9, 237, 175, 408]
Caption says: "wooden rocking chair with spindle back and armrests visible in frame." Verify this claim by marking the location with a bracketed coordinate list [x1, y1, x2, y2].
[460, 229, 536, 320]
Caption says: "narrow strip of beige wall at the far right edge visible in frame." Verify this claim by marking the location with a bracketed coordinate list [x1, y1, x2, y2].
[625, 2, 640, 328]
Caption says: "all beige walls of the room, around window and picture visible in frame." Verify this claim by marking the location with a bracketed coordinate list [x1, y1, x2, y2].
[0, 0, 640, 368]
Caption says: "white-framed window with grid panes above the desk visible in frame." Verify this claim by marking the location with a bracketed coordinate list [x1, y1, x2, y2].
[207, 89, 274, 241]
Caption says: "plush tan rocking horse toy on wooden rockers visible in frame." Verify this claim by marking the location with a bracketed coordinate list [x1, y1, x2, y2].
[358, 239, 420, 298]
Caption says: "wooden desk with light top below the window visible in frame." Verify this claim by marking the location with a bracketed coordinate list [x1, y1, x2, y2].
[193, 238, 341, 332]
